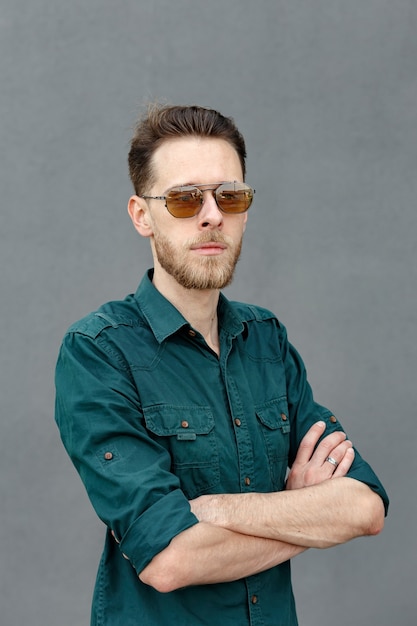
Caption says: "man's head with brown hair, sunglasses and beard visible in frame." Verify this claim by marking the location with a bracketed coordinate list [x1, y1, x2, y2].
[128, 106, 253, 292]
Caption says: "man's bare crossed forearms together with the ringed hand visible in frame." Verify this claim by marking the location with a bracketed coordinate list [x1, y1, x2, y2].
[139, 422, 384, 592]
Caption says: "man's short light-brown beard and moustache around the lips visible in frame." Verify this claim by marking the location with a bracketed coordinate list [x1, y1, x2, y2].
[154, 231, 242, 290]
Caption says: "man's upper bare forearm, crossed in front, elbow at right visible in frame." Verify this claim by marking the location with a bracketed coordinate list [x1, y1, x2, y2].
[191, 478, 384, 548]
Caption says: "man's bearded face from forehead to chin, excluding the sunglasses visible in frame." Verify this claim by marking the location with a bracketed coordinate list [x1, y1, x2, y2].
[143, 137, 247, 289]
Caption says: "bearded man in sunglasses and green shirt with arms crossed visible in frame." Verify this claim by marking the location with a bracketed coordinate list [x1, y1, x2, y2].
[56, 106, 388, 626]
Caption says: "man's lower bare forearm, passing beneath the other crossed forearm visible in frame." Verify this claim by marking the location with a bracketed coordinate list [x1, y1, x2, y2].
[139, 523, 305, 593]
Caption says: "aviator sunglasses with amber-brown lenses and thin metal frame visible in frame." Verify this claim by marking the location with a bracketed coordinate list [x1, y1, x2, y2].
[140, 181, 255, 218]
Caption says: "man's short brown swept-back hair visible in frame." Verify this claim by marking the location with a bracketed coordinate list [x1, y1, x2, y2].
[128, 105, 246, 195]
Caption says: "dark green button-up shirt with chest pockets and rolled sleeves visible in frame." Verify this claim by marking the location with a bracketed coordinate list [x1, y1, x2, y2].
[56, 271, 388, 626]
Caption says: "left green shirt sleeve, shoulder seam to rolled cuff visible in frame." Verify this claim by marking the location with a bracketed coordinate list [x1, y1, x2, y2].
[55, 324, 198, 573]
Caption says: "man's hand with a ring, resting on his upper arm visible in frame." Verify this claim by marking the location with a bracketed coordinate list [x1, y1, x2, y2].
[286, 422, 355, 490]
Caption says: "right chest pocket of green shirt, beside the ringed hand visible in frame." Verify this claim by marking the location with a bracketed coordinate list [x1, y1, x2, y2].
[256, 396, 291, 491]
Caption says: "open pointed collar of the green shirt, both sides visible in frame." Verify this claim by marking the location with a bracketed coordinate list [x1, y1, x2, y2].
[135, 269, 245, 343]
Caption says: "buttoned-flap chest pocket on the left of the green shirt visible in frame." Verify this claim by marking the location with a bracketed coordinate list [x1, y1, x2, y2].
[143, 405, 220, 499]
